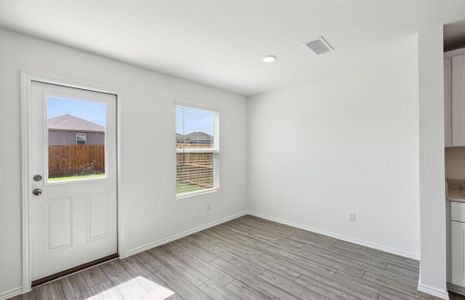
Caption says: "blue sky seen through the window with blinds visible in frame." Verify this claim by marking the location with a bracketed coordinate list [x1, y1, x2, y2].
[176, 105, 215, 135]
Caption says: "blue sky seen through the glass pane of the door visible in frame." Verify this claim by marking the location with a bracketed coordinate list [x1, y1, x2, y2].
[47, 96, 107, 126]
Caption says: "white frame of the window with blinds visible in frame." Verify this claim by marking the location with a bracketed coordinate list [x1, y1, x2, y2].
[174, 103, 220, 199]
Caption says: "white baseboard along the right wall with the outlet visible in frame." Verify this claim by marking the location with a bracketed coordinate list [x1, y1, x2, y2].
[248, 211, 420, 260]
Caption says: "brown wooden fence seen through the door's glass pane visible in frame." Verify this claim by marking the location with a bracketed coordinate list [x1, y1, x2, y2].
[48, 145, 105, 178]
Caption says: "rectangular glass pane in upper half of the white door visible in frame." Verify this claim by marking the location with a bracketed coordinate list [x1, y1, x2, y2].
[47, 96, 106, 182]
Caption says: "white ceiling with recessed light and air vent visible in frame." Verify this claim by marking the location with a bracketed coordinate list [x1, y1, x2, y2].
[0, 0, 465, 95]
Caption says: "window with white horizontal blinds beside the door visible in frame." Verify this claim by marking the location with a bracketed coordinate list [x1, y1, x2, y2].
[176, 105, 219, 196]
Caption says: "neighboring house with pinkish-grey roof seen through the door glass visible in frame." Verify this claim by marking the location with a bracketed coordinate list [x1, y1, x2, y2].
[48, 114, 105, 145]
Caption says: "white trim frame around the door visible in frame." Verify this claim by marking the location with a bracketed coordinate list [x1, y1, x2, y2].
[20, 71, 123, 293]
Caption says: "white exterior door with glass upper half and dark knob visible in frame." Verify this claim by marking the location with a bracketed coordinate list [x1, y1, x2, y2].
[30, 81, 117, 280]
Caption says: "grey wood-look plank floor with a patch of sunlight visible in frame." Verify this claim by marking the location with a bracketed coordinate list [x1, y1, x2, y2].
[10, 216, 465, 300]
